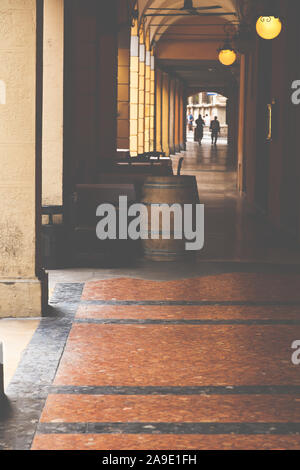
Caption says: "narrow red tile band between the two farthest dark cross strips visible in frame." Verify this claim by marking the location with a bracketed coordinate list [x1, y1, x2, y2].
[76, 305, 300, 320]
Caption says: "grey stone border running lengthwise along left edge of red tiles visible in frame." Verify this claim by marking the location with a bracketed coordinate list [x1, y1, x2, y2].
[0, 284, 84, 450]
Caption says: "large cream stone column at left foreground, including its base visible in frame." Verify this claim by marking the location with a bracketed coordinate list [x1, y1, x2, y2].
[0, 0, 47, 317]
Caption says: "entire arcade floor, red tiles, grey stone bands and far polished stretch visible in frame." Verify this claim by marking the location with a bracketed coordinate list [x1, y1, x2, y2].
[0, 136, 300, 450]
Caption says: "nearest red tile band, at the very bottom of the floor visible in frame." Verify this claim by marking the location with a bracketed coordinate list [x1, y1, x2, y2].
[32, 434, 300, 450]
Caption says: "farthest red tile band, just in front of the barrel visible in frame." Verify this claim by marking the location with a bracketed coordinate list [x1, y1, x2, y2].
[82, 273, 300, 301]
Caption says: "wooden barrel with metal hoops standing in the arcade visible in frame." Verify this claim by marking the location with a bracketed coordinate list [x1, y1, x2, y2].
[141, 176, 199, 261]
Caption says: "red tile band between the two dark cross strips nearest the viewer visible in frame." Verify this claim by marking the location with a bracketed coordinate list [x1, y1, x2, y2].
[41, 395, 300, 423]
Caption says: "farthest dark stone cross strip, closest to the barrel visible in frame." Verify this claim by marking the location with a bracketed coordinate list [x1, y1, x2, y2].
[80, 300, 300, 307]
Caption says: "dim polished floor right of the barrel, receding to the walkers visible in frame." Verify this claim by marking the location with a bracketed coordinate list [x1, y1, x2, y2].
[173, 133, 300, 264]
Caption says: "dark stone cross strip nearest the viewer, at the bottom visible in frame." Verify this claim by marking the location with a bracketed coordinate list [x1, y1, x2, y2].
[38, 423, 300, 435]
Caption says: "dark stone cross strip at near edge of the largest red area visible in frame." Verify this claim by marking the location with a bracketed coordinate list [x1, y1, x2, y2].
[49, 385, 300, 395]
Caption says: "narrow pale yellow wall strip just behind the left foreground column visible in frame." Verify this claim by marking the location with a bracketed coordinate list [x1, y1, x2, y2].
[42, 0, 64, 205]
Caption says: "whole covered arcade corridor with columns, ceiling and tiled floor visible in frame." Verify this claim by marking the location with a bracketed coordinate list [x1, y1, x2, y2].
[0, 0, 300, 450]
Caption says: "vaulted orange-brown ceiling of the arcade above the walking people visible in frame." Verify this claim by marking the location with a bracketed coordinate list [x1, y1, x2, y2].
[138, 0, 239, 91]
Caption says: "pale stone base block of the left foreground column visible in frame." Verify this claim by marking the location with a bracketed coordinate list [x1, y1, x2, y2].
[0, 274, 48, 318]
